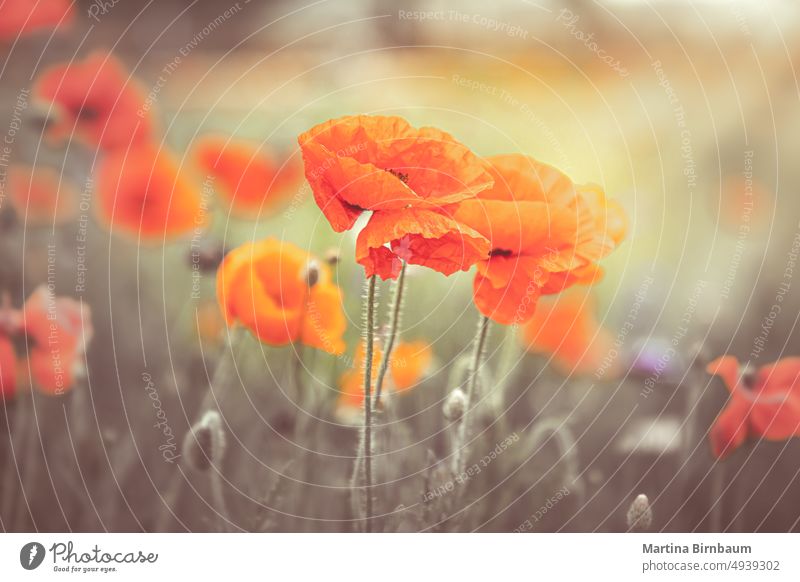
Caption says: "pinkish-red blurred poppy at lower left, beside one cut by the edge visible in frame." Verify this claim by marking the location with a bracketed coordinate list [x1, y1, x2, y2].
[20, 285, 93, 395]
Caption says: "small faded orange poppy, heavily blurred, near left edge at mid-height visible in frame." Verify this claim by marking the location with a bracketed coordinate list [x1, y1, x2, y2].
[7, 165, 78, 226]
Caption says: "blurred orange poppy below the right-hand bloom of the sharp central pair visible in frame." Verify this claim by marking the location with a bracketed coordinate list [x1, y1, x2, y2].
[522, 293, 613, 375]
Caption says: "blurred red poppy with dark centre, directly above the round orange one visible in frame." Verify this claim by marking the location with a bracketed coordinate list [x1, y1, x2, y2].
[34, 52, 153, 151]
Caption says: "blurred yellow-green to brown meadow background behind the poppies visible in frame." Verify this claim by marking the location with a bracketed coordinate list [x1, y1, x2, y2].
[0, 0, 800, 531]
